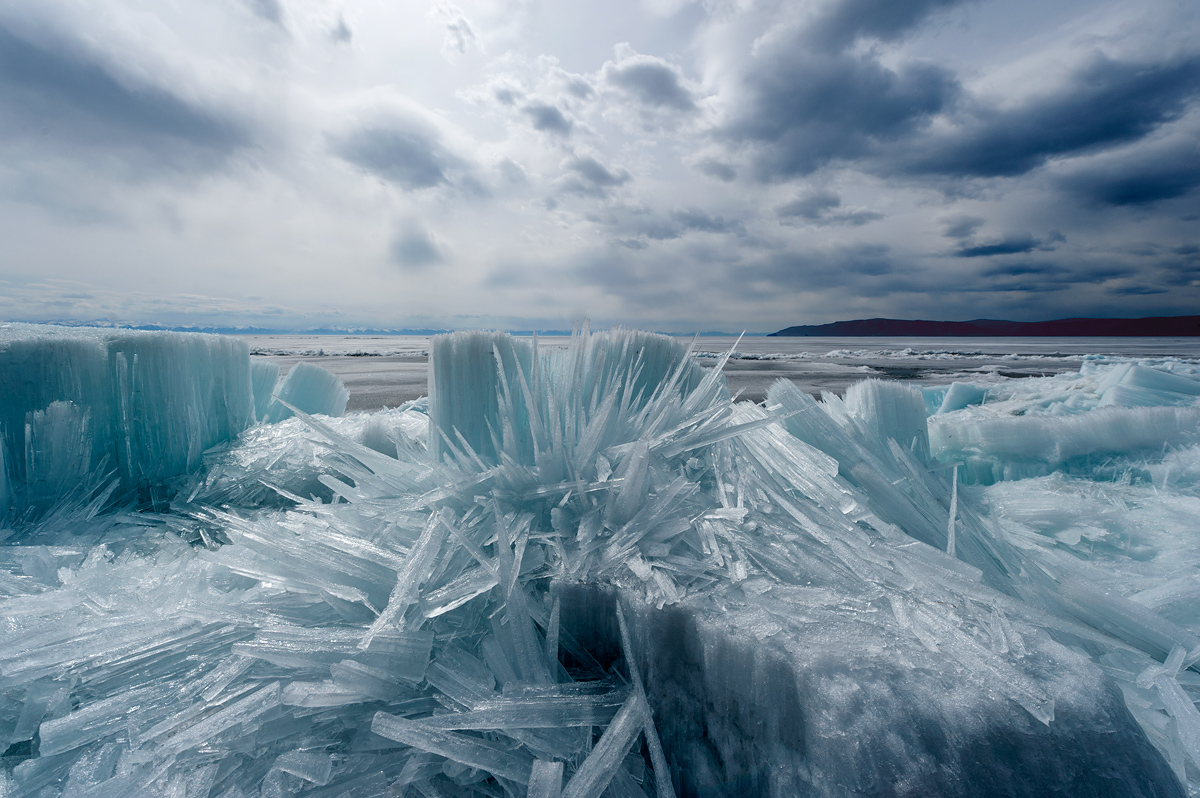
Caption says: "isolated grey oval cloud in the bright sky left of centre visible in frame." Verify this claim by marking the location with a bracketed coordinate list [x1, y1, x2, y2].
[330, 120, 466, 191]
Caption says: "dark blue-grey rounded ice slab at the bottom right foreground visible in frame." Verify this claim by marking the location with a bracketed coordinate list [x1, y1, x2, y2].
[560, 584, 1180, 796]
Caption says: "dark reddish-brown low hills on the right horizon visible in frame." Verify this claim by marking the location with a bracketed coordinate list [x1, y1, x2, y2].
[770, 316, 1200, 338]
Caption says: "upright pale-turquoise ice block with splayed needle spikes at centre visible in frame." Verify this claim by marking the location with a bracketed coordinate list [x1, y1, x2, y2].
[428, 329, 728, 476]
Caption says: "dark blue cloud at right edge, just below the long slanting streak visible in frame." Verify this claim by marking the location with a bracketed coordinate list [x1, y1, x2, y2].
[1058, 132, 1200, 205]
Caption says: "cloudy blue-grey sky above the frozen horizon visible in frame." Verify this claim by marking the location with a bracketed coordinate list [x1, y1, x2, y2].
[0, 0, 1200, 332]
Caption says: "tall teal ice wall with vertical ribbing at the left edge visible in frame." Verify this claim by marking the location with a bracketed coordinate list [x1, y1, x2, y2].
[0, 324, 253, 515]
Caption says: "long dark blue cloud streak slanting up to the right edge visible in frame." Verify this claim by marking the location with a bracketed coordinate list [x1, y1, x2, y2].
[902, 54, 1200, 178]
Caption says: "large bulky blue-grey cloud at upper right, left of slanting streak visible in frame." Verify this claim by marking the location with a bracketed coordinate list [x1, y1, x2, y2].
[719, 40, 960, 181]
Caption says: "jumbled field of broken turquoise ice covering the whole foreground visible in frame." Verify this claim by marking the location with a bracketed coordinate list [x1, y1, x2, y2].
[0, 324, 1200, 798]
